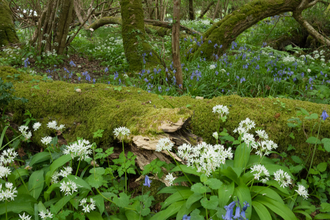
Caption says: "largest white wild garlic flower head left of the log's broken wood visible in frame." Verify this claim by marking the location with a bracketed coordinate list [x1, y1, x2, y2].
[63, 140, 92, 160]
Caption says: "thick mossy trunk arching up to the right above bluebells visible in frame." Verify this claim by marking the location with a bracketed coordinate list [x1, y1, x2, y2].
[189, 0, 323, 59]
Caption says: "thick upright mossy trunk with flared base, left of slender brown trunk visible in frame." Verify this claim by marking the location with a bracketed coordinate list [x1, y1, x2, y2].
[120, 0, 161, 71]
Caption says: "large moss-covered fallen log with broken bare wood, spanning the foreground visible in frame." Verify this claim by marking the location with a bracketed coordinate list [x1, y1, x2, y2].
[0, 67, 330, 167]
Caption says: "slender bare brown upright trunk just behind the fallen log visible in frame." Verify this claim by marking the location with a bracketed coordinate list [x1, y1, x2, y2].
[172, 0, 183, 89]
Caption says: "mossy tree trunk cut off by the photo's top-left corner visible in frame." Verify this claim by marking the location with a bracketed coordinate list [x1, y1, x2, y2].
[0, 0, 19, 47]
